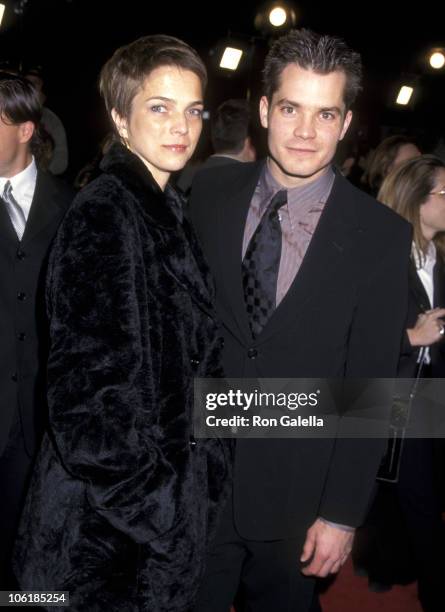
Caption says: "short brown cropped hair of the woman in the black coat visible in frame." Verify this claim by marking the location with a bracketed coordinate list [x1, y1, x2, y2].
[99, 34, 207, 124]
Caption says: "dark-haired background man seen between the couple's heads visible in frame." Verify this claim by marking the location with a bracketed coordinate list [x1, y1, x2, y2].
[176, 99, 256, 194]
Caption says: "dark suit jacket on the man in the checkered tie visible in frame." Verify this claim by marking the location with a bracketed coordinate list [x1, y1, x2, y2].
[190, 163, 411, 540]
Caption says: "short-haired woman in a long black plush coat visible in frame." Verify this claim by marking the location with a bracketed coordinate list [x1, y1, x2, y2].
[15, 36, 228, 612]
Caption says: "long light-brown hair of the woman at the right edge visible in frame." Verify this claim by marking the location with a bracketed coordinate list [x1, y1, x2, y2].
[377, 155, 445, 258]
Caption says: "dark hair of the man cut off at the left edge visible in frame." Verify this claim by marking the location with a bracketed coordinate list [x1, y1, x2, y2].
[0, 72, 42, 156]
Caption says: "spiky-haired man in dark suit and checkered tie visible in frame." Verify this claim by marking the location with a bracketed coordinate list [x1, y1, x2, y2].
[191, 30, 411, 612]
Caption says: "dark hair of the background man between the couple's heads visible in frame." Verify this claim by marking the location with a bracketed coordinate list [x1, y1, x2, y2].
[211, 99, 250, 155]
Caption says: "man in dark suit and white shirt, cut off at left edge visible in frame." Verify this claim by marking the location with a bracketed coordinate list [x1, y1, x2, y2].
[0, 73, 72, 589]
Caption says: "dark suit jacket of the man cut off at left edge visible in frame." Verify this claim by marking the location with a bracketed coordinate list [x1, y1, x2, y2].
[0, 172, 73, 456]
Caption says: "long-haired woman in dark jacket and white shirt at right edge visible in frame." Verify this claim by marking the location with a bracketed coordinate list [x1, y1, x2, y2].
[356, 155, 445, 612]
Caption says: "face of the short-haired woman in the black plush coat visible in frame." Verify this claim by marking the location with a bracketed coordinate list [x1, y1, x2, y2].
[112, 66, 203, 189]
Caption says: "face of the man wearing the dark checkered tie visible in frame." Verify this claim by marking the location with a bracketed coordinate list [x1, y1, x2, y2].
[260, 64, 352, 187]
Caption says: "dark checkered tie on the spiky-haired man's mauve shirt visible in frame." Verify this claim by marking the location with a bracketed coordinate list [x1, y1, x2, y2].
[242, 190, 287, 338]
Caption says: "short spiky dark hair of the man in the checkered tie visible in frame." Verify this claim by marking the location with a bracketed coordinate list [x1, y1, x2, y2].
[263, 29, 362, 109]
